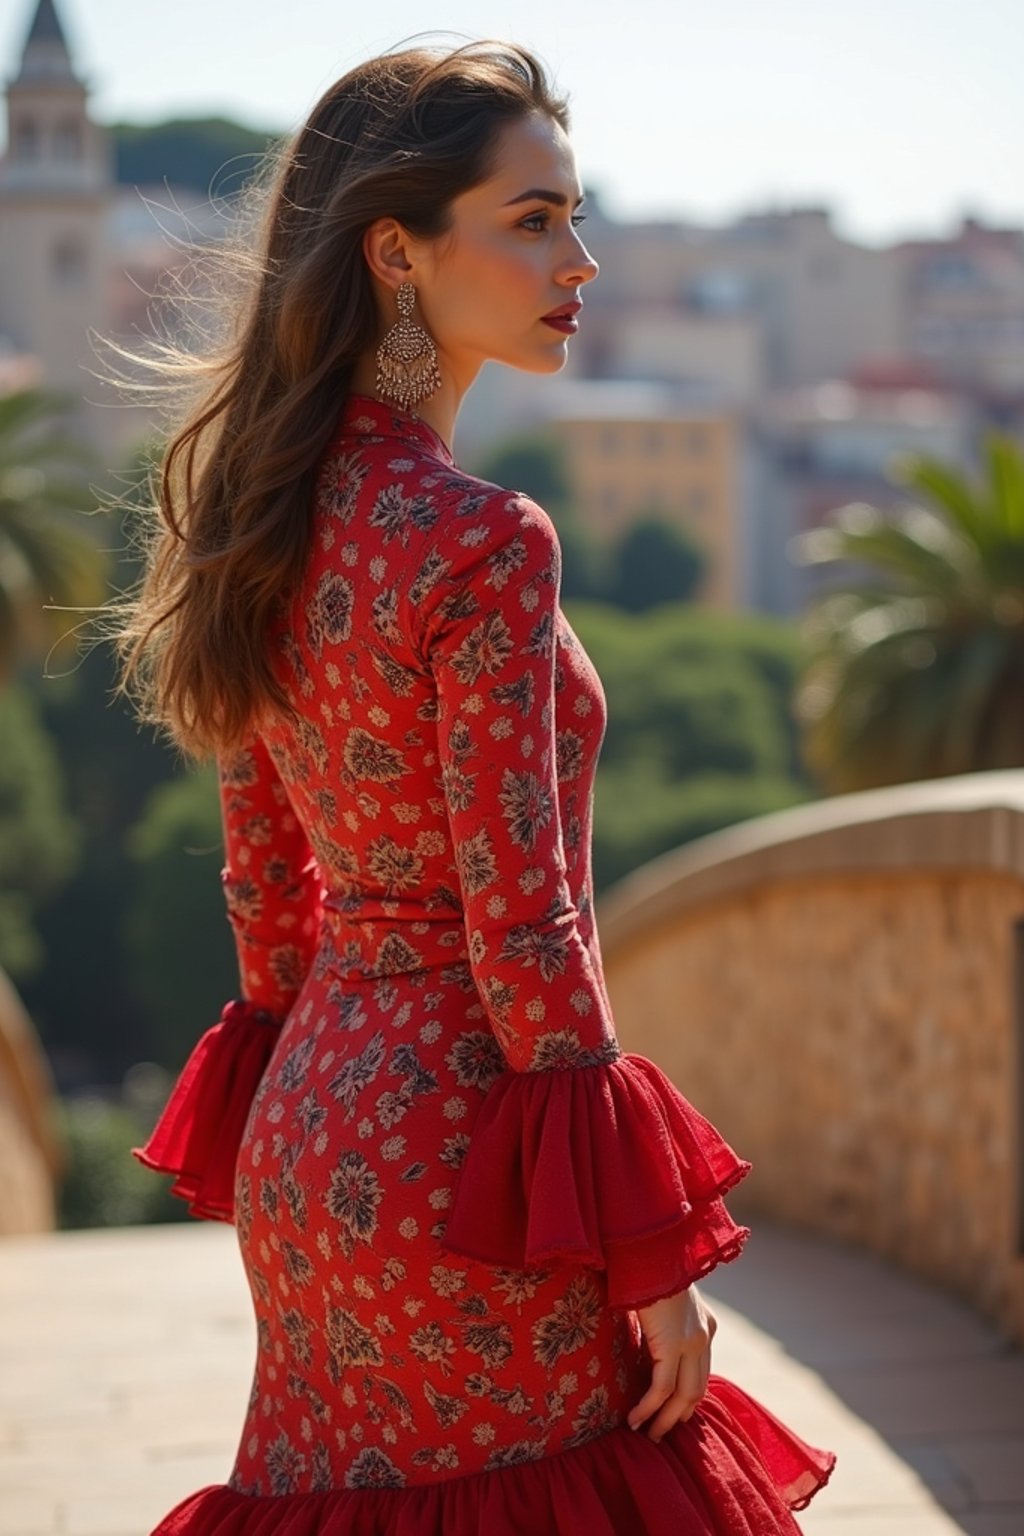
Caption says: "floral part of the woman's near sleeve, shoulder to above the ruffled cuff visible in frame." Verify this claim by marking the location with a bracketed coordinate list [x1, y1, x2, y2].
[414, 495, 619, 1072]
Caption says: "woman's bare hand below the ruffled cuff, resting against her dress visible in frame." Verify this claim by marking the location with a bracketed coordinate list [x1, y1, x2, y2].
[628, 1286, 718, 1441]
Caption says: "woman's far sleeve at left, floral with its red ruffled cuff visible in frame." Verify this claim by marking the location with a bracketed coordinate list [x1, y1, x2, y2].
[132, 737, 324, 1221]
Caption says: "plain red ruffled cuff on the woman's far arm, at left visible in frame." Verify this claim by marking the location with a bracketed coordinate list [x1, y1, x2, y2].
[132, 998, 281, 1221]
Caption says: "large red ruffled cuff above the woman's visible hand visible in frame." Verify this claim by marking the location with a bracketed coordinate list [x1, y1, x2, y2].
[441, 1052, 752, 1309]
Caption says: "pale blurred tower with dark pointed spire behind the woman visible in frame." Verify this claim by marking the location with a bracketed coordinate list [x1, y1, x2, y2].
[0, 0, 112, 445]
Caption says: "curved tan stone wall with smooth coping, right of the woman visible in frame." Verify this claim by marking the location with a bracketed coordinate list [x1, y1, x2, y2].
[597, 773, 1024, 1341]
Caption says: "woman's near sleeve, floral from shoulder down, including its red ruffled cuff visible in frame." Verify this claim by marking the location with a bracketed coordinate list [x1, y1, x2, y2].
[418, 493, 751, 1307]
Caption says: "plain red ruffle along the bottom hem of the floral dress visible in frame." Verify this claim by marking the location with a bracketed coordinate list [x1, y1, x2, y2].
[142, 1373, 835, 1536]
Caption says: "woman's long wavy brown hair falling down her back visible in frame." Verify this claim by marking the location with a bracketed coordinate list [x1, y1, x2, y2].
[111, 41, 568, 759]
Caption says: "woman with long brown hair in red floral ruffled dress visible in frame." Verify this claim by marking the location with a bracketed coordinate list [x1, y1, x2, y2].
[120, 36, 834, 1536]
